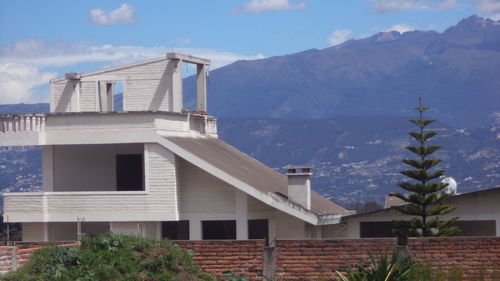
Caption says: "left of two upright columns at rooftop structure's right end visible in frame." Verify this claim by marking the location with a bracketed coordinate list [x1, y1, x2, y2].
[167, 59, 184, 112]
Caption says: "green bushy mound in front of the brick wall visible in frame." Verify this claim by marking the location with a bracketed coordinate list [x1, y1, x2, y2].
[0, 233, 216, 281]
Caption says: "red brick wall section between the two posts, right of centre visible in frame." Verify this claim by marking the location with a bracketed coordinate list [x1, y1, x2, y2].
[276, 239, 395, 280]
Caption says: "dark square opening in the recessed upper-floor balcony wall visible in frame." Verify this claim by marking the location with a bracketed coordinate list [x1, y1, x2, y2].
[116, 154, 144, 191]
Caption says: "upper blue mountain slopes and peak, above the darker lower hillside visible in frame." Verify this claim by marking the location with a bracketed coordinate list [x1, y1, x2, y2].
[185, 16, 500, 127]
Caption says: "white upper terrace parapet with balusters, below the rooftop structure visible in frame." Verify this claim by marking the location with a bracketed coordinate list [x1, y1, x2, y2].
[0, 111, 217, 146]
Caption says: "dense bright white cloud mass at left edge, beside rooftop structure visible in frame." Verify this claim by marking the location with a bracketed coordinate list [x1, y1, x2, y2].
[0, 63, 56, 104]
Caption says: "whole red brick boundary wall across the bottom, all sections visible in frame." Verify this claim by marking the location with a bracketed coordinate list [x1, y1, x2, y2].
[0, 237, 500, 281]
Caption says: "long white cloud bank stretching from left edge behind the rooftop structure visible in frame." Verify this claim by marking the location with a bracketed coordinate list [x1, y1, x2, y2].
[0, 39, 263, 103]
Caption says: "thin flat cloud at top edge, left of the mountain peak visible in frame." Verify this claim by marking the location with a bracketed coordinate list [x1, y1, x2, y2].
[364, 0, 459, 13]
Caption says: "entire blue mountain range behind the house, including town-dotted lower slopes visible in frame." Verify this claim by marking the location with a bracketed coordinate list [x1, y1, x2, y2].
[0, 16, 500, 206]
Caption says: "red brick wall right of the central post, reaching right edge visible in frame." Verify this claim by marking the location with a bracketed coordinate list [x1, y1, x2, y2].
[276, 237, 500, 281]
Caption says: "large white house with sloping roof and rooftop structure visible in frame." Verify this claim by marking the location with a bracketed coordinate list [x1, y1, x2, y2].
[0, 53, 352, 241]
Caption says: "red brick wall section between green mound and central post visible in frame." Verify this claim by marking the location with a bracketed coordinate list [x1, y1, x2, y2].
[176, 240, 264, 281]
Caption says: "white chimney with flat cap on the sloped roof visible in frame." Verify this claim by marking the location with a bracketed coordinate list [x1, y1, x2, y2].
[283, 165, 312, 210]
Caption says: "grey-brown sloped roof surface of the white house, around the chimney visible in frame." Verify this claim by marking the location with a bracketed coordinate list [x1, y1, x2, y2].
[166, 137, 348, 215]
